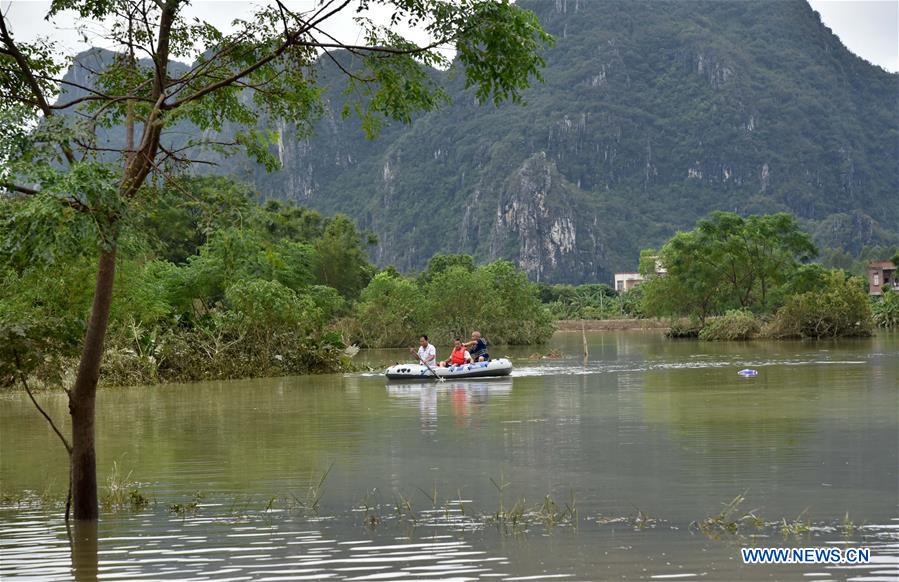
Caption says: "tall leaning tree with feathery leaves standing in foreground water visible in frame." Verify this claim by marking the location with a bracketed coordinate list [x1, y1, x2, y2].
[0, 0, 551, 520]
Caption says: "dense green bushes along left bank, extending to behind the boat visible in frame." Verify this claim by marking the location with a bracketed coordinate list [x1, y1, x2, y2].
[0, 171, 556, 385]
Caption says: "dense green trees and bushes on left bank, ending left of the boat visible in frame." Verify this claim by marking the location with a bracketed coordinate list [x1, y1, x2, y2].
[0, 178, 380, 385]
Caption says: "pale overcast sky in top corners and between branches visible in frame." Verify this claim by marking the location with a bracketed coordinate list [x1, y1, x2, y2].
[0, 0, 899, 72]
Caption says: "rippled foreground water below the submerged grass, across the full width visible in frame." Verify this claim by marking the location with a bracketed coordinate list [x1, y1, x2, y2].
[0, 508, 899, 582]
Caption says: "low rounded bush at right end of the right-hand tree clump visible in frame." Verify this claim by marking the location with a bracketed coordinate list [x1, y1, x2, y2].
[765, 271, 873, 338]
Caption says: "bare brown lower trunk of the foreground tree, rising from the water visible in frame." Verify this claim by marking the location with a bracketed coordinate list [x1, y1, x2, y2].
[69, 247, 116, 521]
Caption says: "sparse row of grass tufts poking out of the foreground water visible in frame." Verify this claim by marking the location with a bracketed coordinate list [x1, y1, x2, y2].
[0, 476, 860, 541]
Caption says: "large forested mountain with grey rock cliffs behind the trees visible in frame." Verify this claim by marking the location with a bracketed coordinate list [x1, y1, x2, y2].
[59, 0, 899, 282]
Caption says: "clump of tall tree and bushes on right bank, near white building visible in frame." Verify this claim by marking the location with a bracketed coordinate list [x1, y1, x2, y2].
[641, 212, 872, 340]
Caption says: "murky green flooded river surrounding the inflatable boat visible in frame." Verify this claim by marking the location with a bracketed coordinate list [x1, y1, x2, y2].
[0, 332, 899, 581]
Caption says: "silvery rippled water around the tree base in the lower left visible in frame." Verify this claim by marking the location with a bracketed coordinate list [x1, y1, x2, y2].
[0, 512, 536, 581]
